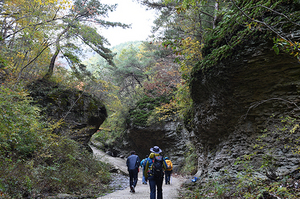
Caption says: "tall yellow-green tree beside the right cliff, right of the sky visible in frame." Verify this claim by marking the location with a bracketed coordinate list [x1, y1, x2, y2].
[135, 0, 212, 118]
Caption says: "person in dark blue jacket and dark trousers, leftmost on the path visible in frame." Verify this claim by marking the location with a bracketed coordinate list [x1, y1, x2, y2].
[126, 151, 140, 193]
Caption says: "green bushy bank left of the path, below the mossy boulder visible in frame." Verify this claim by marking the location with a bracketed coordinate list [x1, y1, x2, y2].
[0, 83, 110, 198]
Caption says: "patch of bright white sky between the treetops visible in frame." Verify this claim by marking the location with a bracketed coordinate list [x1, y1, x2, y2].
[100, 0, 155, 47]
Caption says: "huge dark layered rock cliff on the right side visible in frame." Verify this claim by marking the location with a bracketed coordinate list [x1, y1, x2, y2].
[189, 33, 300, 177]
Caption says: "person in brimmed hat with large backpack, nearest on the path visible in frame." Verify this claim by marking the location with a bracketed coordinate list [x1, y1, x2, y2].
[144, 146, 167, 199]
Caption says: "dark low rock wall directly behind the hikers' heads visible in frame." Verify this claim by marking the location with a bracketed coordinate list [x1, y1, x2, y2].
[126, 121, 188, 170]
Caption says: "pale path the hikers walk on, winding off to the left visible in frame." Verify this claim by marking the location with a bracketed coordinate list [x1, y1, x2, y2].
[91, 146, 185, 199]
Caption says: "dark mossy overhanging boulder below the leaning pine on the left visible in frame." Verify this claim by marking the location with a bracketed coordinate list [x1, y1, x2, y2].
[28, 80, 107, 148]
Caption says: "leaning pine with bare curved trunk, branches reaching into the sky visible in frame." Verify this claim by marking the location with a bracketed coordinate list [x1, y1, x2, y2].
[45, 0, 129, 78]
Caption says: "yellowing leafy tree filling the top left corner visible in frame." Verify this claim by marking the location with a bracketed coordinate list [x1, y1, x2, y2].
[0, 0, 58, 79]
